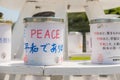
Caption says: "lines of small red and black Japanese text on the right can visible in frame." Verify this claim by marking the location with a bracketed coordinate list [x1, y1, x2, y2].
[94, 31, 120, 50]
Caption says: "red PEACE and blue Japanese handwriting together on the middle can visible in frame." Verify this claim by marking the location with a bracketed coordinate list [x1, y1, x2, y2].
[24, 22, 64, 54]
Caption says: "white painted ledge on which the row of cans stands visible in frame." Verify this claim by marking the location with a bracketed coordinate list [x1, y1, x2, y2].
[0, 61, 120, 80]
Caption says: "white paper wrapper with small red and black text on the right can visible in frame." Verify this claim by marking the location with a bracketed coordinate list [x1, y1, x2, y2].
[90, 22, 120, 64]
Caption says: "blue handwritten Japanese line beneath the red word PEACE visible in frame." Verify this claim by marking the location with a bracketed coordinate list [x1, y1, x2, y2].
[25, 43, 63, 54]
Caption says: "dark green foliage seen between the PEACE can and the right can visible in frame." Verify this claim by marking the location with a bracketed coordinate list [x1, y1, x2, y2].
[68, 12, 89, 32]
